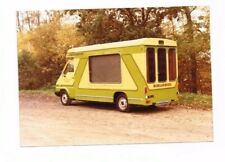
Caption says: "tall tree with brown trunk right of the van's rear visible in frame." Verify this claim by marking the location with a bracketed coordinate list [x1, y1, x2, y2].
[179, 7, 211, 93]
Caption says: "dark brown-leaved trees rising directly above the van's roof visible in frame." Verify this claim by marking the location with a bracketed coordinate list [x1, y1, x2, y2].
[70, 7, 176, 44]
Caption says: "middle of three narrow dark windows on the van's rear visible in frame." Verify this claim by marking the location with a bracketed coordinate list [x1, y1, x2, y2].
[157, 48, 167, 82]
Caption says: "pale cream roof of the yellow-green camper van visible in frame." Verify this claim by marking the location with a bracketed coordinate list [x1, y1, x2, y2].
[67, 38, 177, 54]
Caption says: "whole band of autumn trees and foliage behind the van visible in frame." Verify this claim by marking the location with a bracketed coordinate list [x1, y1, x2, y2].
[17, 6, 211, 94]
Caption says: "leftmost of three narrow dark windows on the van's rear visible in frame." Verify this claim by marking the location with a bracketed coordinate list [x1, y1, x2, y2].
[147, 48, 155, 83]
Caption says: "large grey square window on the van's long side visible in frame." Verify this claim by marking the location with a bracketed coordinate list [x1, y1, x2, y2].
[89, 54, 121, 83]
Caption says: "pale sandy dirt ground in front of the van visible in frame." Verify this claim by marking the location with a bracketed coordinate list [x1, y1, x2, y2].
[20, 94, 213, 146]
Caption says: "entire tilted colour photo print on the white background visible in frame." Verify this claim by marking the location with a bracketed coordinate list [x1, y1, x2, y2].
[15, 6, 213, 146]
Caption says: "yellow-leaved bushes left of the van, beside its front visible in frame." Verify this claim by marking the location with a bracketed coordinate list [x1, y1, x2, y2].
[18, 21, 83, 89]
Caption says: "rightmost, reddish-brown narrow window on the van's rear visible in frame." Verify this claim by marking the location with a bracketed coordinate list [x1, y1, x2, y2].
[168, 48, 177, 81]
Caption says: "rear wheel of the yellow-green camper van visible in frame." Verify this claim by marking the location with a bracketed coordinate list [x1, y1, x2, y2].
[116, 94, 130, 112]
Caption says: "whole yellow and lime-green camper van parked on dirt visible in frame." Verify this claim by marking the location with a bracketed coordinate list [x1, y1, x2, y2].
[55, 38, 178, 112]
